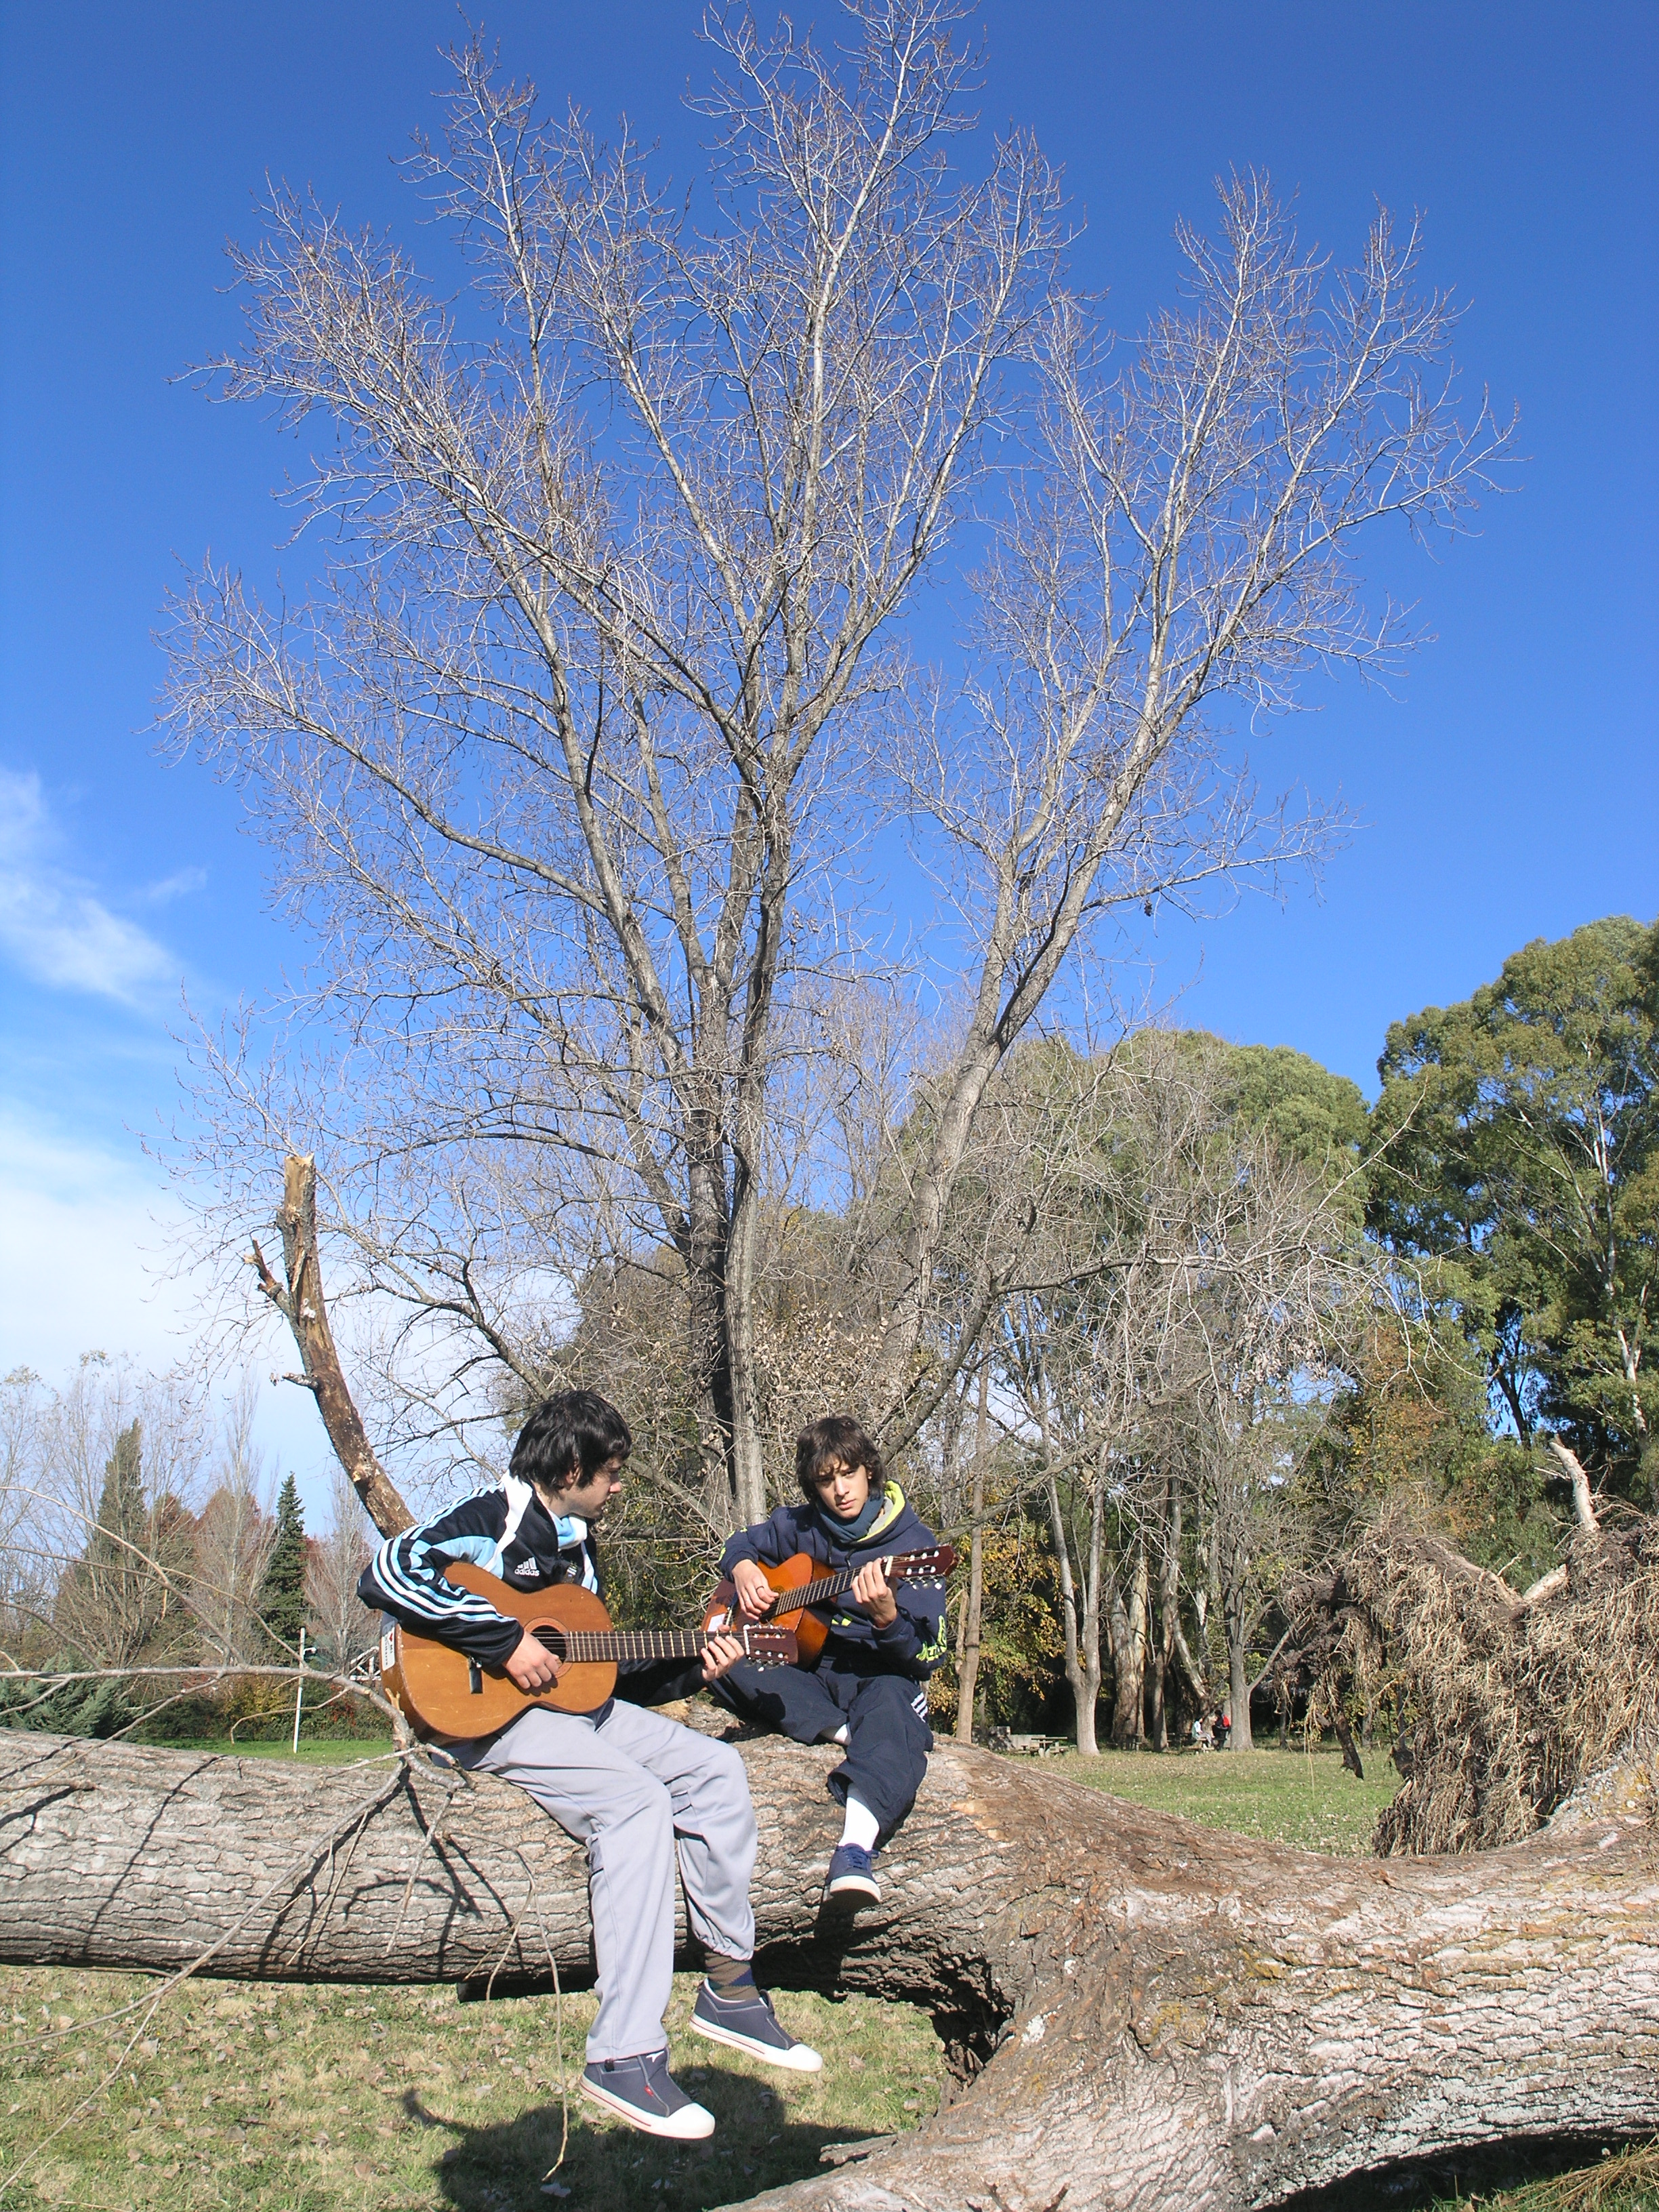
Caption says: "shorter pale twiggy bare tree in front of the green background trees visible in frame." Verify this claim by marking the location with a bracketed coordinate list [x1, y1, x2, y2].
[986, 1031, 1385, 1752]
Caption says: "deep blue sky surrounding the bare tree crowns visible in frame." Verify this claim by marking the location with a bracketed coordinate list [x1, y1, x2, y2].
[0, 0, 1659, 1486]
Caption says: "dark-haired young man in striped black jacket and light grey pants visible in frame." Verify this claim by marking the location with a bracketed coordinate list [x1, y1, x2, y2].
[359, 1391, 823, 2142]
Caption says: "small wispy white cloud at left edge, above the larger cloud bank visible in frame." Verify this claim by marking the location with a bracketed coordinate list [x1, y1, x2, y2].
[0, 768, 179, 1006]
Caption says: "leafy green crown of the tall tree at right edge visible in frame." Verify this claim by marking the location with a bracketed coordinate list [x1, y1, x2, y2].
[1369, 916, 1659, 1491]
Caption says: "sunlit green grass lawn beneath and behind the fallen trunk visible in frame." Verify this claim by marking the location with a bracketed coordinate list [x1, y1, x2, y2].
[0, 1739, 1659, 2212]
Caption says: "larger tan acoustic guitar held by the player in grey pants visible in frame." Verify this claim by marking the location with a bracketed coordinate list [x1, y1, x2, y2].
[380, 1559, 796, 1741]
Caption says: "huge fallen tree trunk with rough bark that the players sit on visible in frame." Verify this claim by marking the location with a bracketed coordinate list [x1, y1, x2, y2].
[0, 1721, 1659, 2212]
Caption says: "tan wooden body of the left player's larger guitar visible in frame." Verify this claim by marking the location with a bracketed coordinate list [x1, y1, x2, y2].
[380, 1559, 617, 1741]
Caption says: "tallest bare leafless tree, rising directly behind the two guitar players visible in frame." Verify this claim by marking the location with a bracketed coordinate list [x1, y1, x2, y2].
[162, 0, 1055, 1522]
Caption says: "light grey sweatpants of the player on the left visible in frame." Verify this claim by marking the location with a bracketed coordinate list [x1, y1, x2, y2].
[455, 1703, 754, 2064]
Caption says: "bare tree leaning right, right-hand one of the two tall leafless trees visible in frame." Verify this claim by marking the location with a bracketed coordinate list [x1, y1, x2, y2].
[882, 177, 1509, 1402]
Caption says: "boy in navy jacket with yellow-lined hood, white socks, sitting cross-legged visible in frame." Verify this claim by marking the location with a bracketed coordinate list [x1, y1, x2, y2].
[714, 1414, 945, 1907]
